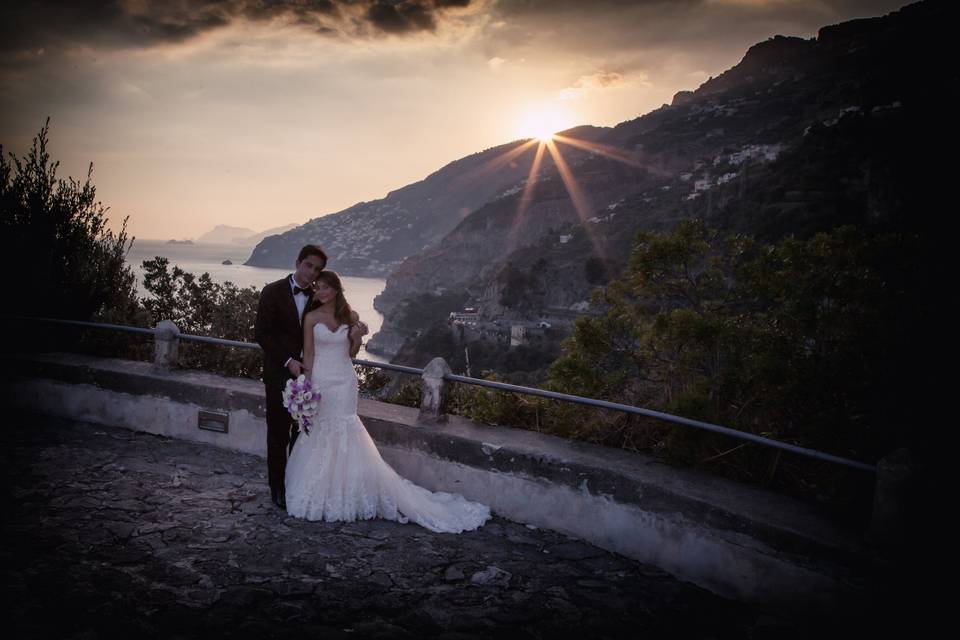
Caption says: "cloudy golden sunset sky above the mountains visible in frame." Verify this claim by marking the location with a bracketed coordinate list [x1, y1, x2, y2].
[0, 0, 906, 239]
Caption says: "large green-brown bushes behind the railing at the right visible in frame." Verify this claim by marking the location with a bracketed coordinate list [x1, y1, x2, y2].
[547, 220, 919, 516]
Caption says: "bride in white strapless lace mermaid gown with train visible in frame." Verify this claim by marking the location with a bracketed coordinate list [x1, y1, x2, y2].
[286, 271, 490, 533]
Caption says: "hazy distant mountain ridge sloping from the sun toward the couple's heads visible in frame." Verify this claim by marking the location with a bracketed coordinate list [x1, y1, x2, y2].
[245, 127, 604, 277]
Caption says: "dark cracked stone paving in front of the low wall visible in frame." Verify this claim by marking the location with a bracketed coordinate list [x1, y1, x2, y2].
[0, 415, 864, 640]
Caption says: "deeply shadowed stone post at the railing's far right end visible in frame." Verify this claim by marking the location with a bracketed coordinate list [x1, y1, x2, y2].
[867, 449, 914, 554]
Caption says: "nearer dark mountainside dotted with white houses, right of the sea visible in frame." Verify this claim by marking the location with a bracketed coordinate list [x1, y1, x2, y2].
[371, 2, 957, 364]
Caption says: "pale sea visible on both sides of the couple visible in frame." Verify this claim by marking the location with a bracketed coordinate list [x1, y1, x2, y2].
[127, 239, 387, 362]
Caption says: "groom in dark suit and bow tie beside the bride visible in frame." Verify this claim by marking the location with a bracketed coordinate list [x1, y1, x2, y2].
[253, 244, 367, 509]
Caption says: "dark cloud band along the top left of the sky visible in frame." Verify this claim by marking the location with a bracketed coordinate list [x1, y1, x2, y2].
[0, 0, 470, 52]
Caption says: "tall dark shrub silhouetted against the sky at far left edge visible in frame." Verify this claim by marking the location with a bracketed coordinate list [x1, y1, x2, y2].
[0, 120, 136, 336]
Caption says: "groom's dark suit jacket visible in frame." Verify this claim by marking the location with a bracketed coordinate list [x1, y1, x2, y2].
[253, 276, 303, 387]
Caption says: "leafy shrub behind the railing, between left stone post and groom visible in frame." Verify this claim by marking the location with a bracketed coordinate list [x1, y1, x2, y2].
[137, 256, 263, 379]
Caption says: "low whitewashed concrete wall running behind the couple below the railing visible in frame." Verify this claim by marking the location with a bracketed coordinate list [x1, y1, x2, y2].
[0, 354, 871, 609]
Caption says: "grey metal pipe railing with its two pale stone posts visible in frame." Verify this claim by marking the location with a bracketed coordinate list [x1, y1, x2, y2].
[0, 315, 877, 473]
